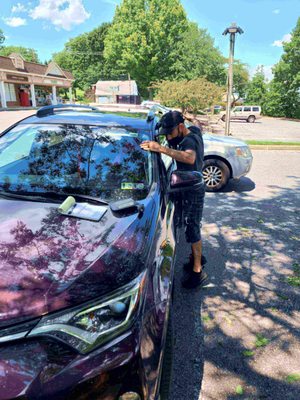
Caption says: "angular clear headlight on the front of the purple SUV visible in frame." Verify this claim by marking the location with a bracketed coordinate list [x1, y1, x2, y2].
[28, 273, 146, 353]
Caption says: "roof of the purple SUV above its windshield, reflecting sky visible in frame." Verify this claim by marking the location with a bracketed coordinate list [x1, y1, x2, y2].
[19, 111, 153, 131]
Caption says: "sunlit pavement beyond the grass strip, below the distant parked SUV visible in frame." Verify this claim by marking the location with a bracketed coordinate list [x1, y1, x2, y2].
[230, 117, 300, 142]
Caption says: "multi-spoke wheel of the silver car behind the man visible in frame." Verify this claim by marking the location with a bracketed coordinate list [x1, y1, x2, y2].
[202, 159, 230, 192]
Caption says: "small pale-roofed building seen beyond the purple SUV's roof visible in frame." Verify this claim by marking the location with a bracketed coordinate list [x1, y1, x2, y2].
[93, 80, 140, 104]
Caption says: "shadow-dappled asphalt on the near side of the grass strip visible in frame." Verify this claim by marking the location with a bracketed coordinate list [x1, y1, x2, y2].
[170, 150, 300, 400]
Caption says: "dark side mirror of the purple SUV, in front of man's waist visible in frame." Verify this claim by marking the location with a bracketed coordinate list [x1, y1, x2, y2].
[168, 171, 204, 193]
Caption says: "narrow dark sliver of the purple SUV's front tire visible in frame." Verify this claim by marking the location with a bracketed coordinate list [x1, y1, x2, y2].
[158, 301, 173, 400]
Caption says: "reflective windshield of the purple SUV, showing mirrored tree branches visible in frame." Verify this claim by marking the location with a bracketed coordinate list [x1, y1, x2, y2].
[0, 125, 152, 201]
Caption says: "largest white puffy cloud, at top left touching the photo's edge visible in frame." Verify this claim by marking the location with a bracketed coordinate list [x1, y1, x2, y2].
[29, 0, 90, 31]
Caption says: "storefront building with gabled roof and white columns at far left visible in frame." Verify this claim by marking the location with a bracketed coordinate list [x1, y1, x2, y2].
[0, 53, 74, 108]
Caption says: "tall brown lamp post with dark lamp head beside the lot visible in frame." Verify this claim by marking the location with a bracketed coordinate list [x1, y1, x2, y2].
[223, 22, 244, 136]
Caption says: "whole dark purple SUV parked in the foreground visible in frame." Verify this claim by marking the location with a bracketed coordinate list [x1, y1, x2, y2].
[0, 106, 202, 400]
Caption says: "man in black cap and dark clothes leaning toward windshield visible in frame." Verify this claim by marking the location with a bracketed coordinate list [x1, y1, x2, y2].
[141, 111, 207, 288]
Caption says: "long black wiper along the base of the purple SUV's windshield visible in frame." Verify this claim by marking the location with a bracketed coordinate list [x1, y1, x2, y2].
[0, 190, 108, 205]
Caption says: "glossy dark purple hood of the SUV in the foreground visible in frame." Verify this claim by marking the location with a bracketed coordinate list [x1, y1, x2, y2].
[0, 197, 156, 326]
